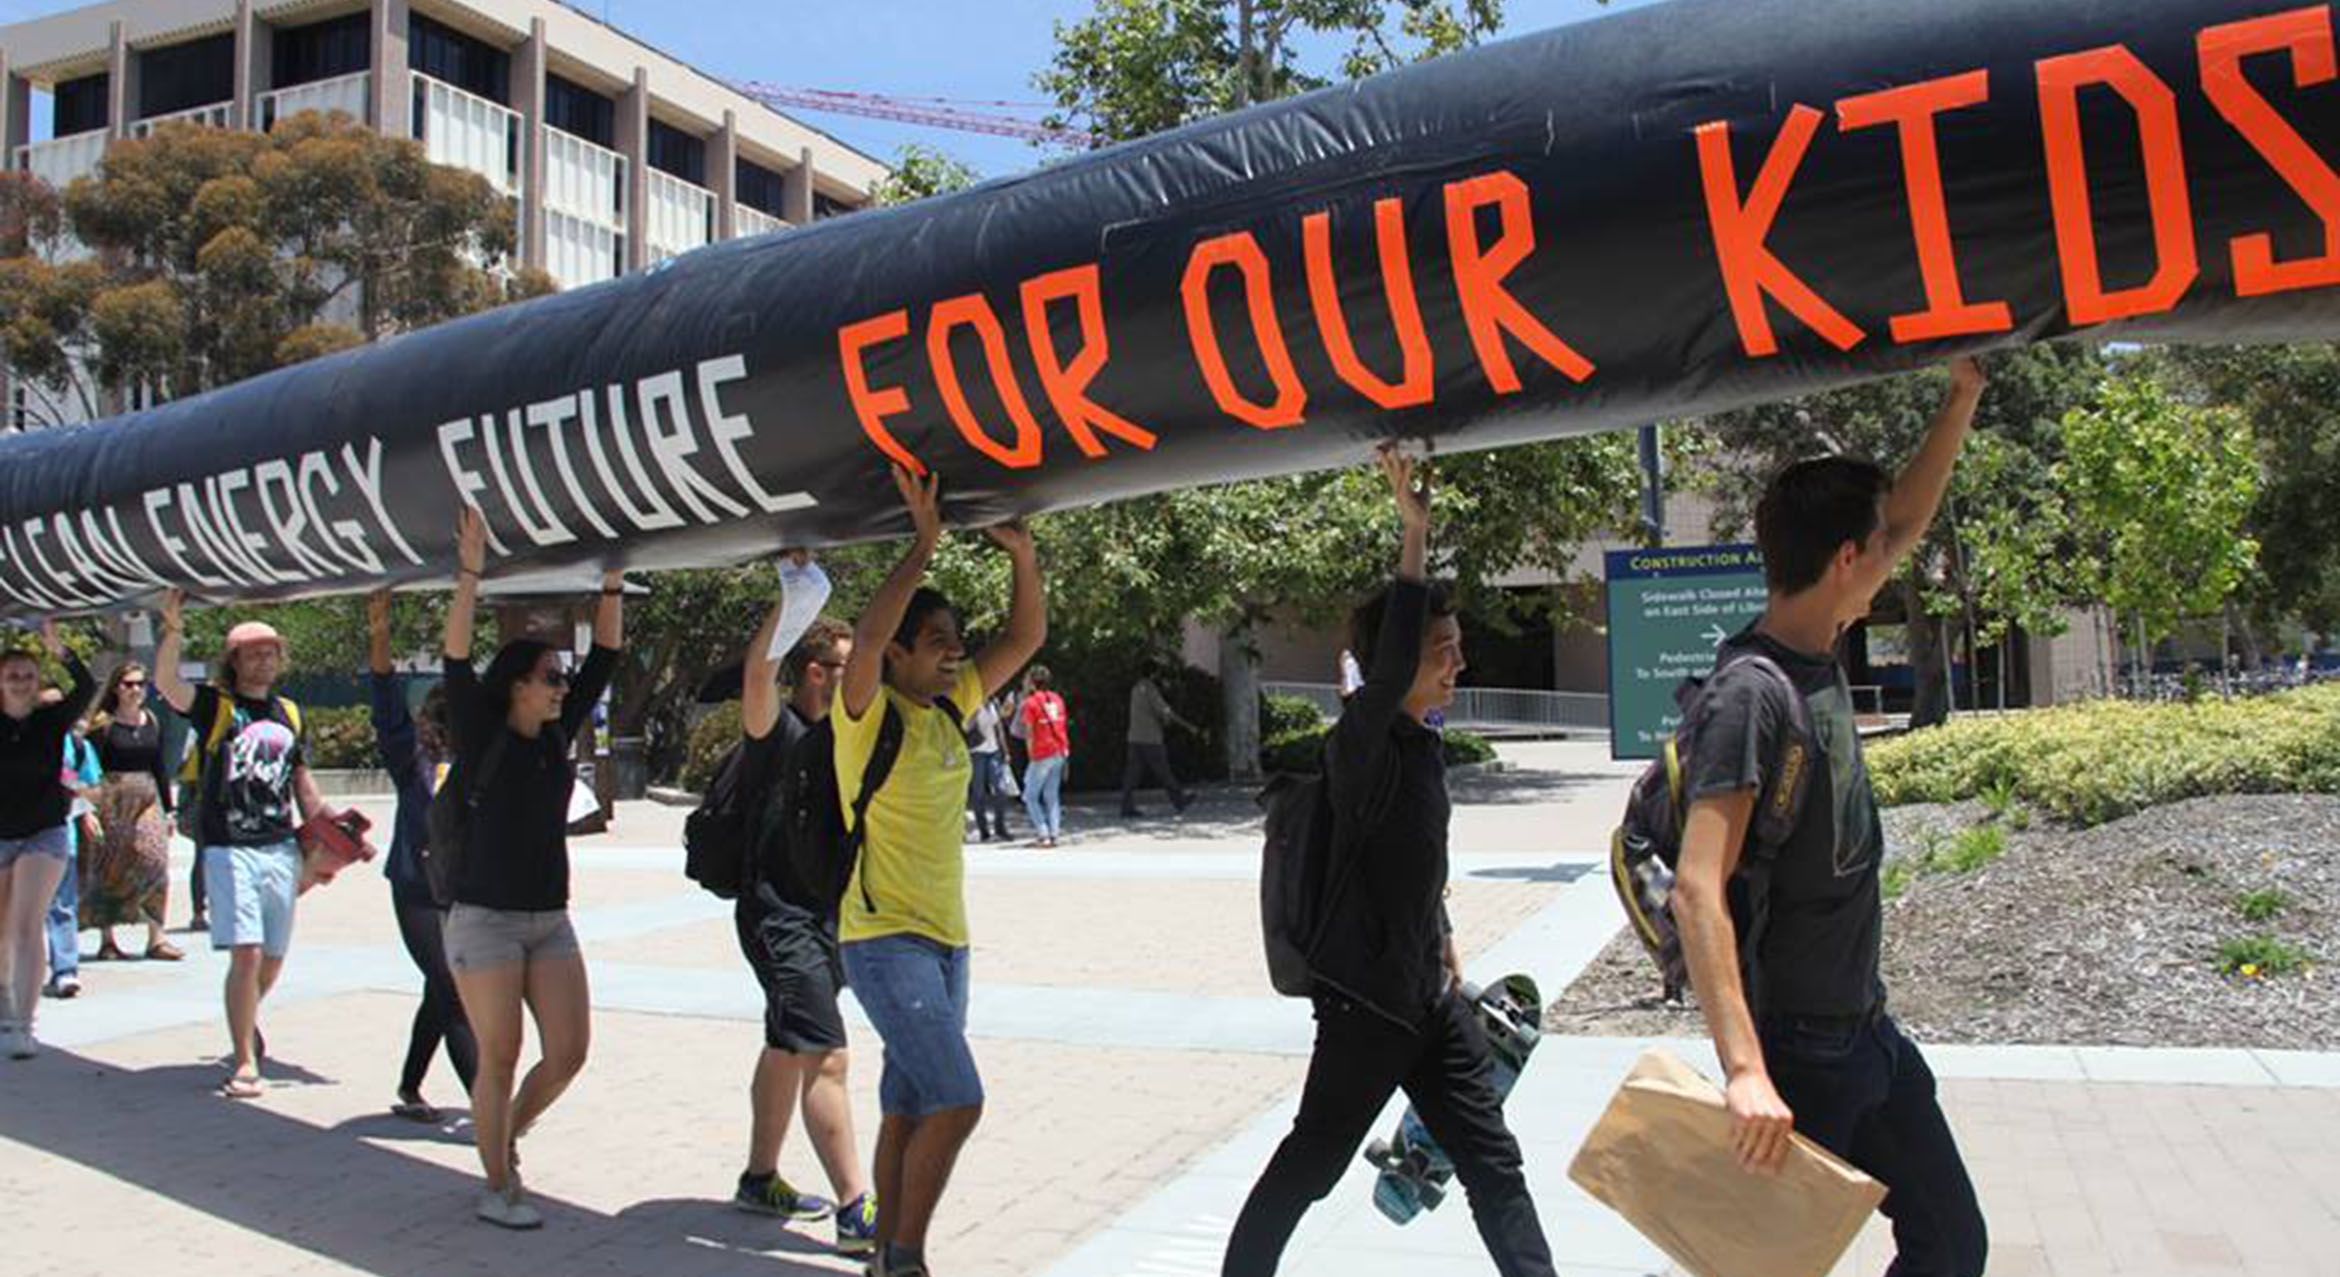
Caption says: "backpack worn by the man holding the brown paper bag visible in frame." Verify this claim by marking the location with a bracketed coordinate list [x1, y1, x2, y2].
[1610, 653, 1816, 1001]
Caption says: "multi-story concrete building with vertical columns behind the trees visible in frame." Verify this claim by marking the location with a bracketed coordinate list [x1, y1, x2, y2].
[0, 0, 887, 374]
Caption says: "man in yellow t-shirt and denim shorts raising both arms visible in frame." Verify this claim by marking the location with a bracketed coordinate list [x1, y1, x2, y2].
[831, 470, 1048, 1277]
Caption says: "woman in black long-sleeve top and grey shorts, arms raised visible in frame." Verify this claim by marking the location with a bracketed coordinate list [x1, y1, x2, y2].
[445, 508, 625, 1228]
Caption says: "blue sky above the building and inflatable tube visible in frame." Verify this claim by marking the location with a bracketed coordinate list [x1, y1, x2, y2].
[0, 0, 1654, 175]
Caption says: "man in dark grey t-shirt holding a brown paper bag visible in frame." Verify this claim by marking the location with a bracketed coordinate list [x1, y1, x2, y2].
[1671, 360, 1987, 1277]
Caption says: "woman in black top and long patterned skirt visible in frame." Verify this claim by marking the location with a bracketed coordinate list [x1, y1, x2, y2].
[80, 662, 185, 961]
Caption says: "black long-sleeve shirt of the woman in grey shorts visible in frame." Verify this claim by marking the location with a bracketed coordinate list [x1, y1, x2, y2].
[447, 646, 618, 912]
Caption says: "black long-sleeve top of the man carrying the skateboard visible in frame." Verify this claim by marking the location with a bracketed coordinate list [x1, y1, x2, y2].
[1310, 578, 1453, 1029]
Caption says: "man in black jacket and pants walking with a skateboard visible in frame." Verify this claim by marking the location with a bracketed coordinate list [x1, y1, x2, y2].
[1221, 444, 1554, 1277]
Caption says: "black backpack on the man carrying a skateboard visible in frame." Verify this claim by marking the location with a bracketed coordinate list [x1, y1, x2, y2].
[1259, 737, 1395, 999]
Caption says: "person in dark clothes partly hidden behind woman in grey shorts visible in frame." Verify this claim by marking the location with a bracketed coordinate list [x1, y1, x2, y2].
[365, 589, 480, 1123]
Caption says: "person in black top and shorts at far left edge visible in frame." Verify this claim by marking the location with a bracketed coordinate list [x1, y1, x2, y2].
[0, 622, 98, 1059]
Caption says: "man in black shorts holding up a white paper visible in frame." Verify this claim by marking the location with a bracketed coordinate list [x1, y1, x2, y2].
[732, 603, 878, 1254]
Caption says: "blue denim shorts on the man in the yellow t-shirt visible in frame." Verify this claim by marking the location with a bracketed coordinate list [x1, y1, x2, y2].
[845, 936, 983, 1118]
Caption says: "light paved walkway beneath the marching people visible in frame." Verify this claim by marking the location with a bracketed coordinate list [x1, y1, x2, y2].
[0, 744, 2340, 1277]
